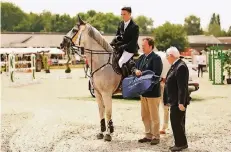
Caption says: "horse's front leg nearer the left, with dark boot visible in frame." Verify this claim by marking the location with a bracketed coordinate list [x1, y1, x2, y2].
[95, 90, 106, 139]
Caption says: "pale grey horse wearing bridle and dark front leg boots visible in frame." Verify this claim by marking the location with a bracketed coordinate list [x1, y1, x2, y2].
[61, 16, 125, 141]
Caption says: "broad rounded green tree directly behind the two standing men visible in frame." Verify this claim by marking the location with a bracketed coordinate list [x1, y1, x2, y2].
[154, 22, 188, 51]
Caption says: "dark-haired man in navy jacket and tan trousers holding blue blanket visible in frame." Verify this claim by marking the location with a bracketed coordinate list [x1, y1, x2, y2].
[132, 38, 163, 145]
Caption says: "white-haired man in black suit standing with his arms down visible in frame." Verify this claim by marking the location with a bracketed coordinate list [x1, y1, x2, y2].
[164, 47, 189, 151]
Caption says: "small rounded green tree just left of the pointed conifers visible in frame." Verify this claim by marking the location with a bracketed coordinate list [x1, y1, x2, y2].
[184, 15, 203, 35]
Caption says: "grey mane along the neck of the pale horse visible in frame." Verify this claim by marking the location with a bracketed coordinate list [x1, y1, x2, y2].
[87, 24, 113, 52]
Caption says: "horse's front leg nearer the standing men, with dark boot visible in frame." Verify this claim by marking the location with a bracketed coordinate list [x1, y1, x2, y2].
[102, 93, 114, 141]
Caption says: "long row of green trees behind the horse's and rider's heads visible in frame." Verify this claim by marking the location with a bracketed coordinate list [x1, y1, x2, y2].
[1, 3, 153, 34]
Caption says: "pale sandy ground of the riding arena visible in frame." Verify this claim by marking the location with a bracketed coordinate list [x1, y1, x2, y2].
[1, 69, 231, 152]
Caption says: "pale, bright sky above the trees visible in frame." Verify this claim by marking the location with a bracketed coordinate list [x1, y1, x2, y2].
[1, 0, 231, 30]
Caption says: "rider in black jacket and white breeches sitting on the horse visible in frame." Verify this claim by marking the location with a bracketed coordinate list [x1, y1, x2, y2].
[111, 7, 139, 76]
